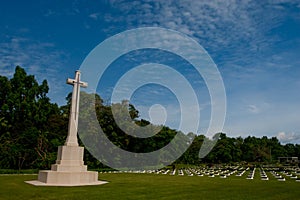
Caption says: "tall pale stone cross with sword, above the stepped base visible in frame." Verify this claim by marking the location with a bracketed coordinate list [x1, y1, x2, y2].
[65, 70, 88, 146]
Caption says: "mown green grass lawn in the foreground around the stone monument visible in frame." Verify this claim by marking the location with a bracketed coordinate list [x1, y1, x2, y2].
[0, 173, 300, 200]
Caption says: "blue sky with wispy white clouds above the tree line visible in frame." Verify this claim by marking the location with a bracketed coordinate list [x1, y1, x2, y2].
[0, 0, 300, 143]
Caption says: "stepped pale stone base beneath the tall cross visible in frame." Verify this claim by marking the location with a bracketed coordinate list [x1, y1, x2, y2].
[27, 146, 106, 186]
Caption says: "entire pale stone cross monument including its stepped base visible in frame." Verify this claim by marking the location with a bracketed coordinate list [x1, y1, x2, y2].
[26, 71, 106, 186]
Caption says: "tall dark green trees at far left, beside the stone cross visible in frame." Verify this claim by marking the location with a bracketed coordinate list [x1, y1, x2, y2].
[0, 66, 65, 169]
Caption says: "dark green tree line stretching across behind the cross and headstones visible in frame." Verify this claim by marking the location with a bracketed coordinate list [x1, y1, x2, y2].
[0, 66, 300, 170]
